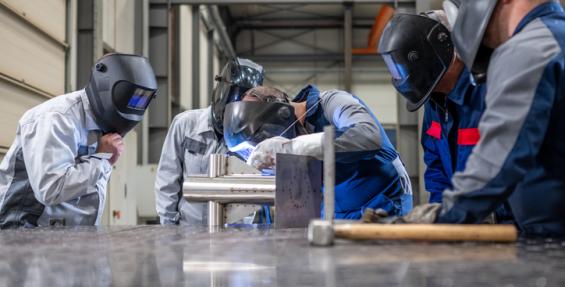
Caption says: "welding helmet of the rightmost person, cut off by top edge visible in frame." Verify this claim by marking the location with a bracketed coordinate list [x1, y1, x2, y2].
[450, 0, 497, 83]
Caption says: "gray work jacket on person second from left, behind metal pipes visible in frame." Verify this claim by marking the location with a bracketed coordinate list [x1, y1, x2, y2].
[155, 107, 227, 225]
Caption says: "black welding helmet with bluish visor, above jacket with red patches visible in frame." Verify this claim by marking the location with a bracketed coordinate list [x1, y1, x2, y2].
[379, 14, 455, 112]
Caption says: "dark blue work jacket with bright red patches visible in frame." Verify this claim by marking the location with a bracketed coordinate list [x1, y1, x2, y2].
[421, 69, 486, 205]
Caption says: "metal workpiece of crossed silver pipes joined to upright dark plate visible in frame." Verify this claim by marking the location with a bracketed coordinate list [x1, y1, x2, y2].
[183, 154, 322, 228]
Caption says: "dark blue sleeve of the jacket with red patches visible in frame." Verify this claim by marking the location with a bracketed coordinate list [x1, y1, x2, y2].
[422, 103, 450, 203]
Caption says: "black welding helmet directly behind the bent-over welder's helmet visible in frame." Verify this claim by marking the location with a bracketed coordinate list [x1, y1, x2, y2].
[212, 58, 265, 134]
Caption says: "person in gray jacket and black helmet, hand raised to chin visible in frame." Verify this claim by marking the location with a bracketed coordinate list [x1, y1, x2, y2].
[0, 54, 157, 229]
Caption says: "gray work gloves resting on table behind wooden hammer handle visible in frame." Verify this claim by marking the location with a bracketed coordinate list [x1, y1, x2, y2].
[362, 203, 441, 224]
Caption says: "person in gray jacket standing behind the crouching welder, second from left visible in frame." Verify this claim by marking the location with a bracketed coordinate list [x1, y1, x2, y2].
[155, 58, 264, 225]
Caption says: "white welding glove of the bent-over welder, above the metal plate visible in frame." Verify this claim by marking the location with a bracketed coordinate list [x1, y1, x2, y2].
[247, 133, 324, 170]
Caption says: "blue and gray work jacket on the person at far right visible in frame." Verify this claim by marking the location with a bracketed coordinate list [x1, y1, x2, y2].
[438, 2, 565, 237]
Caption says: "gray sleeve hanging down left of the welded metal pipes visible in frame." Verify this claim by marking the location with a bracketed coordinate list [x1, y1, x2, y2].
[155, 117, 184, 224]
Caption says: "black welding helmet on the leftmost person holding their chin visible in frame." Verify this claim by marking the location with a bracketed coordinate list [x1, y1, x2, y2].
[85, 53, 157, 136]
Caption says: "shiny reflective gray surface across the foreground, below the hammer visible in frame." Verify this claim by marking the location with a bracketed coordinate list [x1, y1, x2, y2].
[0, 226, 565, 287]
